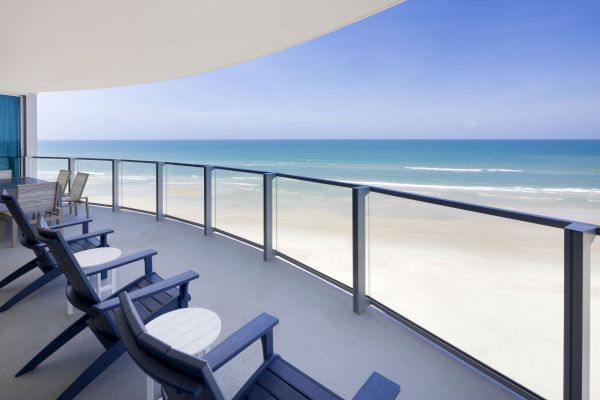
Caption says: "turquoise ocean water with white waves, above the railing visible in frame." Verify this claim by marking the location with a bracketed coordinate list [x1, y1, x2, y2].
[39, 140, 600, 220]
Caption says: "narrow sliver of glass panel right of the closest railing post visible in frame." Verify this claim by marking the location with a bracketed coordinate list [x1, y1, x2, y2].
[590, 236, 600, 399]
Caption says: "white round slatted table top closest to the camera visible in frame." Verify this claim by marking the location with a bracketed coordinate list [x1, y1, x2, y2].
[146, 307, 221, 355]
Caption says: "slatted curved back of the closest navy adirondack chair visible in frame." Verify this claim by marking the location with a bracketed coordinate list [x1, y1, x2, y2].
[116, 292, 224, 400]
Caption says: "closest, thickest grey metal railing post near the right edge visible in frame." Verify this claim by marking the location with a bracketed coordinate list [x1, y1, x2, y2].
[563, 223, 596, 400]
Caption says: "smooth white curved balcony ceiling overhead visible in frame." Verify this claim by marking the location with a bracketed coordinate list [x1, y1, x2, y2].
[0, 0, 401, 94]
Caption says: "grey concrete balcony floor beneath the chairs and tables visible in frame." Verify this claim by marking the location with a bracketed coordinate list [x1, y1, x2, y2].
[0, 207, 518, 400]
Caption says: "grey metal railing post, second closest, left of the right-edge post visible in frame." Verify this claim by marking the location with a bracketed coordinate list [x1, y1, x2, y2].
[352, 186, 369, 314]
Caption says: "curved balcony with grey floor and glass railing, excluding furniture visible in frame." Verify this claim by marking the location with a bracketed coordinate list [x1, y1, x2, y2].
[0, 158, 600, 399]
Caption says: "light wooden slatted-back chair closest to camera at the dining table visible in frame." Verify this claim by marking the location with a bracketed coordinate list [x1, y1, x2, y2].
[0, 182, 63, 247]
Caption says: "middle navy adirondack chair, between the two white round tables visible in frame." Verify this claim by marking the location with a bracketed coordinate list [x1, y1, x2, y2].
[16, 226, 198, 399]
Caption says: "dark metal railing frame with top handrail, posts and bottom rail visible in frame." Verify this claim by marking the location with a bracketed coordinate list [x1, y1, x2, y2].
[32, 156, 600, 400]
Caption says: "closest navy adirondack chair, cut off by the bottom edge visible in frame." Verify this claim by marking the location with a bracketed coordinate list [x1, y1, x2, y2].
[116, 291, 400, 400]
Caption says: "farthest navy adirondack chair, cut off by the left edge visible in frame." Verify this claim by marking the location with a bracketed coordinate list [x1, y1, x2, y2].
[0, 193, 114, 312]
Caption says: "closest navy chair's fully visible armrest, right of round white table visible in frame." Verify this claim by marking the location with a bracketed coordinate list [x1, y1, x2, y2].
[202, 313, 279, 371]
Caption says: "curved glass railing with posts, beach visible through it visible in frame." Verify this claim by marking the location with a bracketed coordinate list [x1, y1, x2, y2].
[29, 157, 600, 400]
